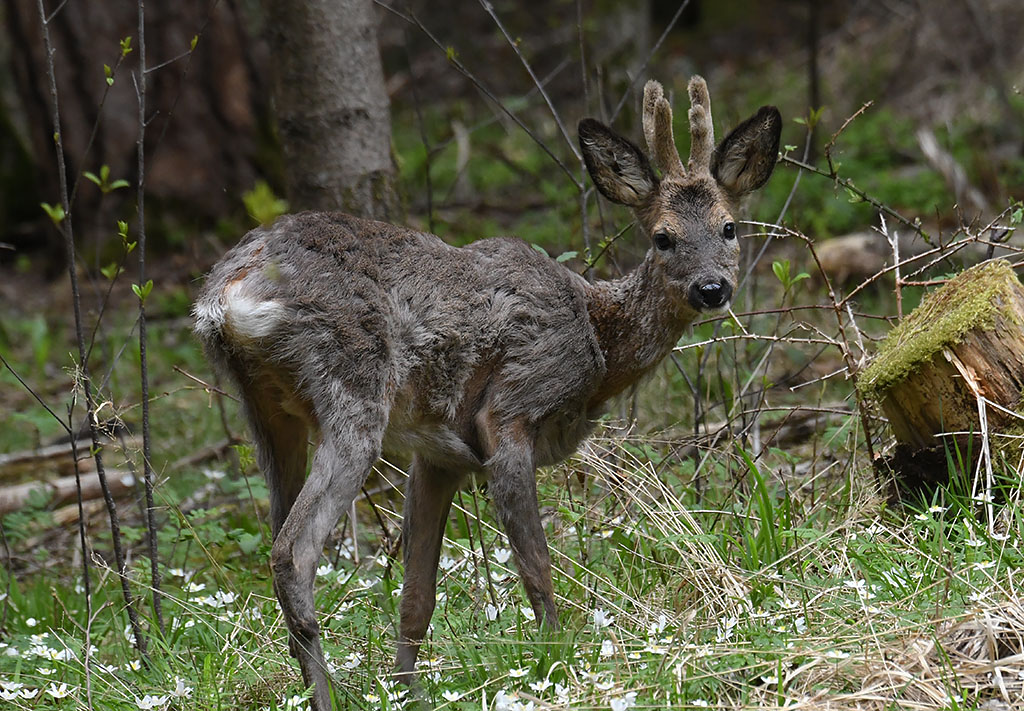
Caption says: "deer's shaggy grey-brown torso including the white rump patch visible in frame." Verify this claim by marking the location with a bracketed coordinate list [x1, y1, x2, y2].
[196, 212, 604, 473]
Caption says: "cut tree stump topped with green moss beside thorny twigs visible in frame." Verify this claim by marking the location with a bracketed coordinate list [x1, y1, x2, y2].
[857, 260, 1024, 450]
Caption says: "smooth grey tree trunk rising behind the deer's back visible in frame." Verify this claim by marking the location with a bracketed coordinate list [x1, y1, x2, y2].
[266, 0, 400, 220]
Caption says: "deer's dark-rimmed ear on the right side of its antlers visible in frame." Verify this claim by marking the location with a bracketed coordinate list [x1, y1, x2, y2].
[711, 107, 782, 200]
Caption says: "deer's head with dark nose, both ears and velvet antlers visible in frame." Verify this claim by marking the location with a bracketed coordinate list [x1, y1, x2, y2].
[579, 77, 782, 323]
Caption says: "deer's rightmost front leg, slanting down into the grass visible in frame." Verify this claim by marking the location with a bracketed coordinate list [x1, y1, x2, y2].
[487, 438, 558, 629]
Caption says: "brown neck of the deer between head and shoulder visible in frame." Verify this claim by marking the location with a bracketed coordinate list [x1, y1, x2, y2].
[588, 258, 693, 407]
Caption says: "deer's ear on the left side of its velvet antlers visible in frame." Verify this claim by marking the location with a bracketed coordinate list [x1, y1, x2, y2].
[580, 119, 657, 207]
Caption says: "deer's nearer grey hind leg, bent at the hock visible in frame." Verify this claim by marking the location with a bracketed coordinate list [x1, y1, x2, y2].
[270, 396, 387, 711]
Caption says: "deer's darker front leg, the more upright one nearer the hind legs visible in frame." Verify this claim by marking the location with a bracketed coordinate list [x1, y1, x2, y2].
[395, 457, 459, 682]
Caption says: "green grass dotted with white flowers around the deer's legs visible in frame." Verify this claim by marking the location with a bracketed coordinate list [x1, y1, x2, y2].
[0, 411, 1022, 709]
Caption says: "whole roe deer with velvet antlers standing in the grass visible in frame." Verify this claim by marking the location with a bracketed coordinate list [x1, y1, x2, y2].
[195, 77, 781, 711]
